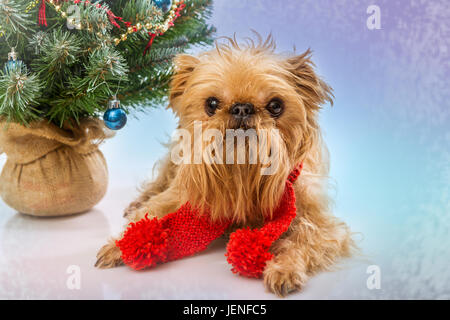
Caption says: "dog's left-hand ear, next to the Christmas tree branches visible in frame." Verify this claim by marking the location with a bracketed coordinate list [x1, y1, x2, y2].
[169, 54, 200, 104]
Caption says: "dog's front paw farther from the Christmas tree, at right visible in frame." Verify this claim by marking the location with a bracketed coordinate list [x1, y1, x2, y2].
[263, 257, 308, 297]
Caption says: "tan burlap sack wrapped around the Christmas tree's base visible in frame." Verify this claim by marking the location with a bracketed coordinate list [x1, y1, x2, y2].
[0, 119, 112, 216]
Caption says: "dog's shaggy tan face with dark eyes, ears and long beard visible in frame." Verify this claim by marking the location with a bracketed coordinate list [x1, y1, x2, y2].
[170, 38, 331, 221]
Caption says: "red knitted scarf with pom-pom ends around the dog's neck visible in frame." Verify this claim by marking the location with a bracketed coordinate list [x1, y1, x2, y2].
[116, 164, 303, 278]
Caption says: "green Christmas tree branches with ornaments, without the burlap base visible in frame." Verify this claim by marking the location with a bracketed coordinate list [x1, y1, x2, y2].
[0, 0, 214, 127]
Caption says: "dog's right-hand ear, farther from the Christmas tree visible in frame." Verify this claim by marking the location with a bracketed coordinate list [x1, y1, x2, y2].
[286, 49, 334, 110]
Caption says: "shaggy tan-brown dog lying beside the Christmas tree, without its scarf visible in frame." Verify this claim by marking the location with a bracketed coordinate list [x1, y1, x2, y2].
[96, 36, 354, 296]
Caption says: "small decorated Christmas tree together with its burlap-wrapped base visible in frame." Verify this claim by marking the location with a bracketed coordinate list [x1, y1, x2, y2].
[0, 0, 214, 216]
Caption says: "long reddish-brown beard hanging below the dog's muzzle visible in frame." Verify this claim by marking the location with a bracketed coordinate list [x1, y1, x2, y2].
[178, 128, 291, 225]
